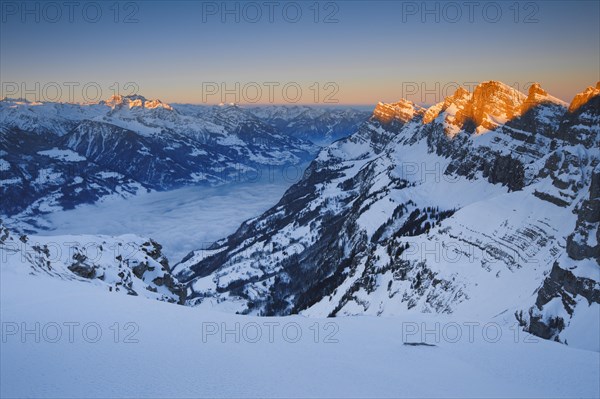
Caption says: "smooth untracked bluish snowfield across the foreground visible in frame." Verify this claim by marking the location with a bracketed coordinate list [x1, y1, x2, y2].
[0, 268, 600, 398]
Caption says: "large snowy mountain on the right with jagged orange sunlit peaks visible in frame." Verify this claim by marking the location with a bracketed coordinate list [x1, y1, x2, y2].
[174, 81, 600, 350]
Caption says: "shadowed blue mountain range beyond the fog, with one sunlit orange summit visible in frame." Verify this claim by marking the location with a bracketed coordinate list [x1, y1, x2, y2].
[0, 95, 369, 225]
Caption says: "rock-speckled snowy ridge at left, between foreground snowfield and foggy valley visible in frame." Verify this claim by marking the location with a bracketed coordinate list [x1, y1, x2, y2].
[0, 224, 185, 303]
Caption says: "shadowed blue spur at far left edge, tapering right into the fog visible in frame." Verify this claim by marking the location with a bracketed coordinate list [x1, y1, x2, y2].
[0, 129, 150, 226]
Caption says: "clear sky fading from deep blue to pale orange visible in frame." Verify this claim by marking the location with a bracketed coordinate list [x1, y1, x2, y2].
[0, 0, 600, 104]
